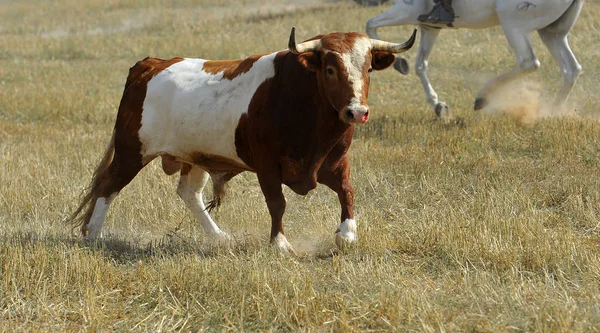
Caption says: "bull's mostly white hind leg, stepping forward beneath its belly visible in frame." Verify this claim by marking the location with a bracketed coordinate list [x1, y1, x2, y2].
[177, 166, 230, 239]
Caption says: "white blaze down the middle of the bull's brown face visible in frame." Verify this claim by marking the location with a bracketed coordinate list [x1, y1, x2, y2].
[340, 38, 371, 107]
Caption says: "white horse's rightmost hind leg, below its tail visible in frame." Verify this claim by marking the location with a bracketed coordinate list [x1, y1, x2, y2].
[538, 29, 581, 109]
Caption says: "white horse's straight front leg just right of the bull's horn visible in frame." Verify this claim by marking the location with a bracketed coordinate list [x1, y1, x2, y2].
[415, 27, 450, 117]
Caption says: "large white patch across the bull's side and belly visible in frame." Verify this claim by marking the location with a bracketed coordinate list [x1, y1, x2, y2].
[139, 53, 277, 166]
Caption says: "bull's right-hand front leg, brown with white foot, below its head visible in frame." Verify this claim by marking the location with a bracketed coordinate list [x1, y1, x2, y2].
[318, 156, 357, 250]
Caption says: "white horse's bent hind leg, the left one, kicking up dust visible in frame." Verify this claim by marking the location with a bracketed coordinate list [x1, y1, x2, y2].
[474, 27, 540, 110]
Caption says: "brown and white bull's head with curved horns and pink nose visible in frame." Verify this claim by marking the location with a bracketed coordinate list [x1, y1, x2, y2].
[289, 28, 417, 124]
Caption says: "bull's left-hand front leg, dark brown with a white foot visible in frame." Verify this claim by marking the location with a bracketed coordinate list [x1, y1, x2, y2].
[258, 173, 296, 254]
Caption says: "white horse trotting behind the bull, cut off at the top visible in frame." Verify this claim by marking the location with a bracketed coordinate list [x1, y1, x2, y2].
[367, 0, 585, 117]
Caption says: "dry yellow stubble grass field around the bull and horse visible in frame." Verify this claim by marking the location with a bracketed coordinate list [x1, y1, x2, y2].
[0, 0, 600, 332]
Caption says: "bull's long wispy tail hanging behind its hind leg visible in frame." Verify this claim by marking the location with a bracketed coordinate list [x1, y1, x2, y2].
[67, 130, 115, 232]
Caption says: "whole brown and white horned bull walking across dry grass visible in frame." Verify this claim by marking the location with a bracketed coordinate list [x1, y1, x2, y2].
[71, 28, 416, 251]
